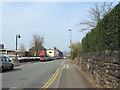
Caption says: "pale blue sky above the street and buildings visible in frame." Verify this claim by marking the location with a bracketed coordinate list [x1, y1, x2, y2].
[1, 2, 118, 51]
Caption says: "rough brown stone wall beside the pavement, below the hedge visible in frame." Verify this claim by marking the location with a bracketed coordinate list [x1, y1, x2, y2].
[77, 50, 120, 88]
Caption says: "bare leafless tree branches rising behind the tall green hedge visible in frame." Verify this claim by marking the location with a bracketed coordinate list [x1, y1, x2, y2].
[79, 2, 113, 32]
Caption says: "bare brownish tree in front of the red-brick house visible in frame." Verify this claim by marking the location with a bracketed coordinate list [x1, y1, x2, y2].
[31, 34, 44, 56]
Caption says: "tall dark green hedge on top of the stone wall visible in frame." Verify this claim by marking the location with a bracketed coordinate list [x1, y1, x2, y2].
[82, 3, 120, 52]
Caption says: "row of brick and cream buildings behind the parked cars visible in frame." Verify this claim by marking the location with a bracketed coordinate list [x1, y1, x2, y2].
[0, 45, 63, 57]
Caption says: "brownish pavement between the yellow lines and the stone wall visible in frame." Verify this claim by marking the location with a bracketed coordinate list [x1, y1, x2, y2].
[58, 61, 92, 88]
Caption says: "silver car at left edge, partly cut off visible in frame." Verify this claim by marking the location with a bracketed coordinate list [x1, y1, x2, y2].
[0, 56, 14, 72]
